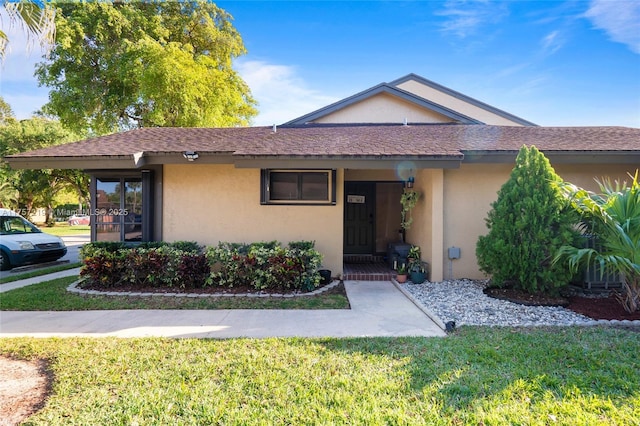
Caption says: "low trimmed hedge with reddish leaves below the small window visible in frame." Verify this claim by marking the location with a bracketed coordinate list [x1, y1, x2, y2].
[80, 241, 322, 291]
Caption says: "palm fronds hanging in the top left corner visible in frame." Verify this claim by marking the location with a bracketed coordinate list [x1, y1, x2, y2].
[0, 0, 56, 62]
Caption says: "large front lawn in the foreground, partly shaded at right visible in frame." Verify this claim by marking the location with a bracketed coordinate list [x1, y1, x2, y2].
[0, 327, 640, 425]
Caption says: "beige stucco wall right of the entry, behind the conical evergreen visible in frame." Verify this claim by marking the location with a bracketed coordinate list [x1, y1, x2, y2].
[442, 164, 631, 279]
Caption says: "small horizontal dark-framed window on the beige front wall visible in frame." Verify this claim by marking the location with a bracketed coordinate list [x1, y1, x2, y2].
[260, 169, 336, 205]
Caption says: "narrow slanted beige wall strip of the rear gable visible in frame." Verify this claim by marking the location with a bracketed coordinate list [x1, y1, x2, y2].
[398, 80, 521, 126]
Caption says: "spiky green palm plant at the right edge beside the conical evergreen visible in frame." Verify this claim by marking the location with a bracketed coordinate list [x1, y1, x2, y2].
[554, 170, 640, 312]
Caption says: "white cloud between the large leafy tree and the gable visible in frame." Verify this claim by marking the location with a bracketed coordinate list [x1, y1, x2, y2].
[236, 61, 339, 126]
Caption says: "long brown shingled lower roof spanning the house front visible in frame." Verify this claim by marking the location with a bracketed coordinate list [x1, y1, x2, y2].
[9, 125, 640, 158]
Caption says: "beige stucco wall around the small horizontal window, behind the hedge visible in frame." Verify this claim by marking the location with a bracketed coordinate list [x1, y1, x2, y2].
[163, 164, 344, 276]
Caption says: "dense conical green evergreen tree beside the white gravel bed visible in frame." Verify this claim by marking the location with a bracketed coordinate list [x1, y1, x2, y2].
[476, 146, 577, 293]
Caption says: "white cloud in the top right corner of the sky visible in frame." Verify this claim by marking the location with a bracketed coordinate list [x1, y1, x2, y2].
[585, 0, 640, 54]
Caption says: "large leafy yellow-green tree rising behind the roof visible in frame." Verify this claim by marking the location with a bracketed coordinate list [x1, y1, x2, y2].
[36, 0, 257, 134]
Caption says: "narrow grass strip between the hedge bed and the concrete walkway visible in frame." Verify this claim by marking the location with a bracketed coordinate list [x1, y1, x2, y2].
[0, 277, 349, 311]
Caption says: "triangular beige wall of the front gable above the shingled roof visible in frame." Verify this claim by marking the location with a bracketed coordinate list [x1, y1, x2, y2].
[315, 93, 453, 124]
